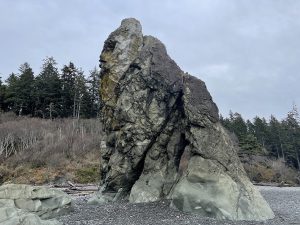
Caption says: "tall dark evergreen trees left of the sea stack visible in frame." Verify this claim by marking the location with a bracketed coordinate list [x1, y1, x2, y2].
[0, 57, 100, 119]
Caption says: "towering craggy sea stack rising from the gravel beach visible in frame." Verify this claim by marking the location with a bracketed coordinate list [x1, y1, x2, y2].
[92, 19, 274, 220]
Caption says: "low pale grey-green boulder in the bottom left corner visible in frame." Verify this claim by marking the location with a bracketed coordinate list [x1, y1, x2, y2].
[0, 184, 71, 225]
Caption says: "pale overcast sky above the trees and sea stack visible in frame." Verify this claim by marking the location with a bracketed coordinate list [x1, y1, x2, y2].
[0, 0, 300, 119]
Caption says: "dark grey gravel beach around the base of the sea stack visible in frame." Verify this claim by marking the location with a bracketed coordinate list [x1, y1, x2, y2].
[58, 187, 300, 225]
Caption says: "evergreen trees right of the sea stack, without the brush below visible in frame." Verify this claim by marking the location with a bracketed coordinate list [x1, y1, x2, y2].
[220, 105, 300, 170]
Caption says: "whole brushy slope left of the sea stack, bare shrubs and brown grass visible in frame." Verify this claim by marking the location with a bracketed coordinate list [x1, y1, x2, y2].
[0, 112, 102, 184]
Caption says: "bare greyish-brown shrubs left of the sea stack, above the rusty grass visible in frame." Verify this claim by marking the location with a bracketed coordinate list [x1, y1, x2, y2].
[0, 118, 102, 165]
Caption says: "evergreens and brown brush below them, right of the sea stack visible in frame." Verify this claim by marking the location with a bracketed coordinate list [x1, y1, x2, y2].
[221, 106, 300, 184]
